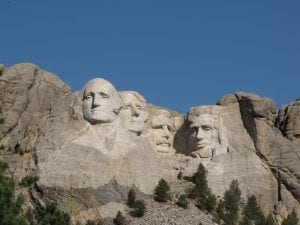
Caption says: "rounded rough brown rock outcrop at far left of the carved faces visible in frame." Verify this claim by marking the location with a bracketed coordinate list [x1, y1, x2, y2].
[0, 63, 71, 183]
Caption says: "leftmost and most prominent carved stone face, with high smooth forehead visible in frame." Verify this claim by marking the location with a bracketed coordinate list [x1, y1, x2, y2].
[83, 78, 120, 124]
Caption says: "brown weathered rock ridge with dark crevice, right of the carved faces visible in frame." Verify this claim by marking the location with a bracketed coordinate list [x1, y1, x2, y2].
[218, 92, 300, 216]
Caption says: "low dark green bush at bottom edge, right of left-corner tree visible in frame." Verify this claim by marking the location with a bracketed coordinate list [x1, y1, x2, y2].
[32, 203, 71, 225]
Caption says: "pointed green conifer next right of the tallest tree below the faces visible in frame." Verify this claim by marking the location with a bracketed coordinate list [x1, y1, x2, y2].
[217, 180, 241, 225]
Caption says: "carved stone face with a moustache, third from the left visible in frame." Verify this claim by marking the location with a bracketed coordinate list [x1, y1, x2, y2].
[149, 110, 173, 153]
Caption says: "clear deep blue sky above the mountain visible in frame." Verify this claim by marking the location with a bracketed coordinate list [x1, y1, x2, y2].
[0, 0, 300, 113]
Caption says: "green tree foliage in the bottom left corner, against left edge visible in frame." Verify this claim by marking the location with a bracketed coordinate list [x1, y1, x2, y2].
[0, 161, 28, 225]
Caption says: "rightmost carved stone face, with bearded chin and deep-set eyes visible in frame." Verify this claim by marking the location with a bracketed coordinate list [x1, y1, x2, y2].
[188, 107, 220, 158]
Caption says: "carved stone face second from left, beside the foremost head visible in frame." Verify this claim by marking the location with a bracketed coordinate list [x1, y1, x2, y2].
[120, 91, 148, 135]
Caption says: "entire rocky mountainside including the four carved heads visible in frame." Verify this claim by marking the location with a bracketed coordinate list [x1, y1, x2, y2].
[0, 64, 300, 222]
